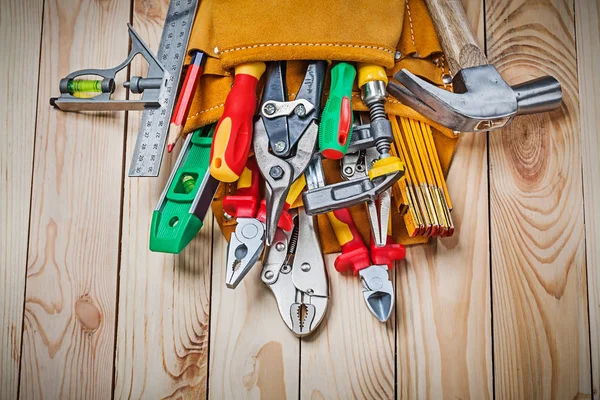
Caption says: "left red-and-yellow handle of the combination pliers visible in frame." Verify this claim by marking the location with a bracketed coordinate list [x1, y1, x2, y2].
[223, 157, 260, 218]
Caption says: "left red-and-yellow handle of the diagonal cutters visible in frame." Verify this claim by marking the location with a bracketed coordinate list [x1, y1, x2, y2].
[327, 208, 371, 275]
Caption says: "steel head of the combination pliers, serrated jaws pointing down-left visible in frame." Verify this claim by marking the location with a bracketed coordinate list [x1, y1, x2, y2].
[225, 218, 265, 289]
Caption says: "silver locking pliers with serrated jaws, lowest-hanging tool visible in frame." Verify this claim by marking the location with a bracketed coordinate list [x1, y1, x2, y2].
[261, 207, 329, 337]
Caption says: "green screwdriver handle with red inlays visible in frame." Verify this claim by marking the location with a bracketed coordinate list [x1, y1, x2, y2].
[319, 62, 356, 160]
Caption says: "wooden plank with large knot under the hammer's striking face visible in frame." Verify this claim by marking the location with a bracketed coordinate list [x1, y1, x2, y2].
[486, 0, 591, 399]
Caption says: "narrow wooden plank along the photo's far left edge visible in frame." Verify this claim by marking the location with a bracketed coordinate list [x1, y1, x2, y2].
[0, 0, 43, 399]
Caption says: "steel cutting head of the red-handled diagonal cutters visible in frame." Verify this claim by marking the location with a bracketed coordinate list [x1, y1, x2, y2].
[358, 265, 394, 322]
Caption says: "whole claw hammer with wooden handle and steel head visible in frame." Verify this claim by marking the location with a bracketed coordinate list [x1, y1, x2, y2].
[388, 0, 562, 132]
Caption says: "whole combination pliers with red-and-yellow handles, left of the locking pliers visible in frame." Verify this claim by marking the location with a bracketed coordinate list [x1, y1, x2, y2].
[223, 157, 306, 289]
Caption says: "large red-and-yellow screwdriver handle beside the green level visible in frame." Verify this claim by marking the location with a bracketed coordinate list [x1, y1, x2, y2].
[210, 62, 265, 182]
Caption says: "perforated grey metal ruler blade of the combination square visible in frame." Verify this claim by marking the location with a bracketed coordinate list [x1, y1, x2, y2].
[129, 0, 198, 176]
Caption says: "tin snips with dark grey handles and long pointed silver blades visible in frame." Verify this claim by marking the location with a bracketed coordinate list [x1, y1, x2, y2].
[254, 61, 327, 246]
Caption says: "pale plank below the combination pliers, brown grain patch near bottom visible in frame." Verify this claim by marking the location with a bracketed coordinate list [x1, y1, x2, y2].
[208, 228, 300, 399]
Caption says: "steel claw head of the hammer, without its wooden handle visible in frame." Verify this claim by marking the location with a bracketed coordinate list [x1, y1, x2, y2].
[388, 65, 562, 132]
